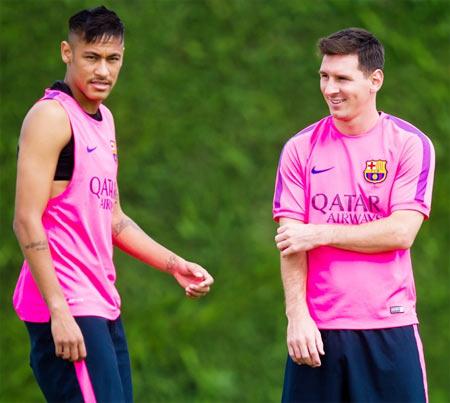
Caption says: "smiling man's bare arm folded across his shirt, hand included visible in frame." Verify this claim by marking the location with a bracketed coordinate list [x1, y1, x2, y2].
[275, 210, 423, 256]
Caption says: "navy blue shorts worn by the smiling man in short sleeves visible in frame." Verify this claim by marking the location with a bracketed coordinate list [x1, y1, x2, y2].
[282, 325, 427, 403]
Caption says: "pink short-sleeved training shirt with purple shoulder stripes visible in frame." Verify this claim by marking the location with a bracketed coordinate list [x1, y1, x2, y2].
[273, 113, 434, 329]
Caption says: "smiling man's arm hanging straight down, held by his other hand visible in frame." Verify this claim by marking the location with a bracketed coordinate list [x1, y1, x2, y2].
[280, 218, 324, 367]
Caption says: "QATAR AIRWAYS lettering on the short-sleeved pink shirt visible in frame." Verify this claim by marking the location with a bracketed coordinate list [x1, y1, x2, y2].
[311, 193, 383, 224]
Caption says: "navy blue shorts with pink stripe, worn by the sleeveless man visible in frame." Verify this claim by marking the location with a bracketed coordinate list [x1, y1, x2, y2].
[25, 316, 133, 403]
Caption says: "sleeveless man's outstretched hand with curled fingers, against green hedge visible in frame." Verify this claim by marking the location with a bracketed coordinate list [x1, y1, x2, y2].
[173, 260, 214, 298]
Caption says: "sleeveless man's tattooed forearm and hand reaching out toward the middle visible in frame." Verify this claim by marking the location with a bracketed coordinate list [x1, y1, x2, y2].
[112, 193, 214, 298]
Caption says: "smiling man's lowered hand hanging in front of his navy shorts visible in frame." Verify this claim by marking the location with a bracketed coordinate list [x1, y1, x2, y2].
[287, 315, 325, 367]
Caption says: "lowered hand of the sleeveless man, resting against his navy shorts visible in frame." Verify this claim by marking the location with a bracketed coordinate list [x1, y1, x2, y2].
[51, 312, 87, 362]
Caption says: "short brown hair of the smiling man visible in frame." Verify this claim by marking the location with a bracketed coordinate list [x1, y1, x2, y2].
[318, 28, 384, 75]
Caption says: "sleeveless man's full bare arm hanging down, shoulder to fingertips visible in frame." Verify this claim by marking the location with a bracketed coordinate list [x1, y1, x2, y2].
[14, 101, 86, 360]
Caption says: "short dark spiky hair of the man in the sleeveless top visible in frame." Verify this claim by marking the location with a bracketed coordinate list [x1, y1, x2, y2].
[69, 6, 125, 43]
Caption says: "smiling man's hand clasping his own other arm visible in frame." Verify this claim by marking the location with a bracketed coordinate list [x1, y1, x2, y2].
[275, 223, 326, 256]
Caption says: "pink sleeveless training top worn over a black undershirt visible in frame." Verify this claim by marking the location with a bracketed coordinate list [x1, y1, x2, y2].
[13, 90, 120, 322]
